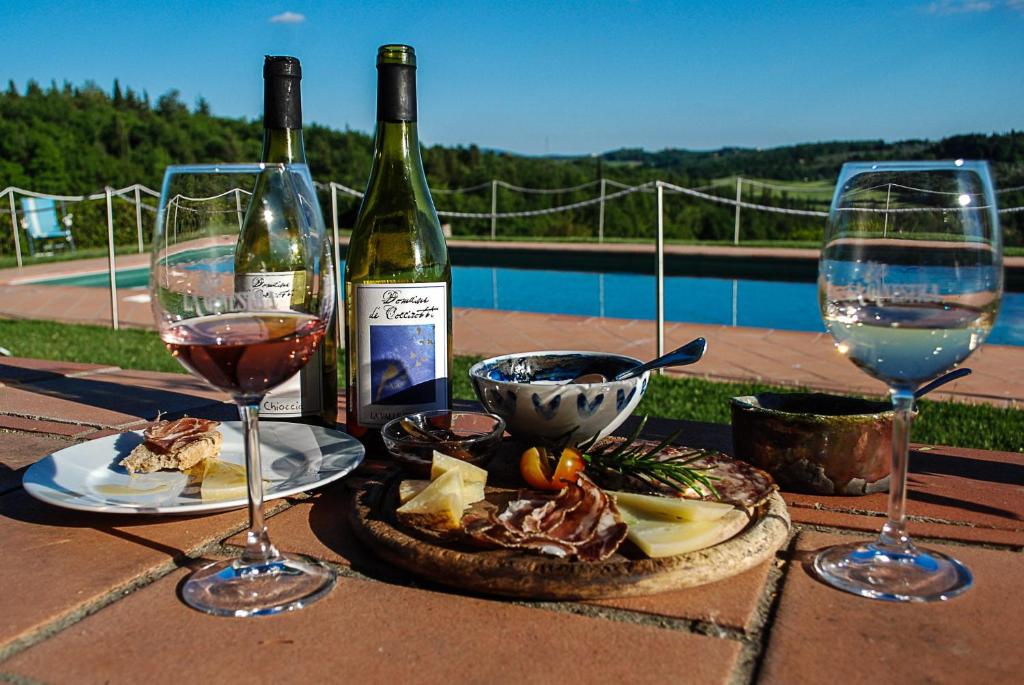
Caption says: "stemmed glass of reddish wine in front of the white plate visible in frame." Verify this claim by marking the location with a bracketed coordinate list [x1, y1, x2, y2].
[150, 164, 335, 616]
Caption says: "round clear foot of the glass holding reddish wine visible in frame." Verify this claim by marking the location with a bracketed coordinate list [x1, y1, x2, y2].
[181, 554, 336, 617]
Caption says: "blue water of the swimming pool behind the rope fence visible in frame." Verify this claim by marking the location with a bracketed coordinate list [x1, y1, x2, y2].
[36, 262, 1024, 345]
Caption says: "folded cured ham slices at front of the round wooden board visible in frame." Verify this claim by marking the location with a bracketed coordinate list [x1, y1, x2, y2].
[462, 474, 626, 561]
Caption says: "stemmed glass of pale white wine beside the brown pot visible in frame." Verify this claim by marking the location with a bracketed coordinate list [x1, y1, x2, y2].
[814, 160, 1002, 602]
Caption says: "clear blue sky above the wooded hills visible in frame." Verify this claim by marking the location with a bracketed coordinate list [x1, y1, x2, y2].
[0, 0, 1024, 154]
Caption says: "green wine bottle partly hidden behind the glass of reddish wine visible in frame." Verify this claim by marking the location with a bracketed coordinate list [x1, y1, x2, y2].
[234, 55, 338, 428]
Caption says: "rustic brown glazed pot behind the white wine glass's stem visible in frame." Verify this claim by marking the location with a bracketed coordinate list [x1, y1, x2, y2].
[732, 392, 893, 495]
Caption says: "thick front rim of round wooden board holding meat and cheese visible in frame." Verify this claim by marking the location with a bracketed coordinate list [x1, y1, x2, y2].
[350, 476, 790, 599]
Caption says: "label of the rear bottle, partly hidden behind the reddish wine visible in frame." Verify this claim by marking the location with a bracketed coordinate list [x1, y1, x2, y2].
[234, 271, 324, 418]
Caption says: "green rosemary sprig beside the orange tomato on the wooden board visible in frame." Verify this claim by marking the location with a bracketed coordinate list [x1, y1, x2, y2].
[581, 417, 719, 498]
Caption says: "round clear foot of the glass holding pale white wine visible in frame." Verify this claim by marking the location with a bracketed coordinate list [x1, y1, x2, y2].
[814, 543, 973, 602]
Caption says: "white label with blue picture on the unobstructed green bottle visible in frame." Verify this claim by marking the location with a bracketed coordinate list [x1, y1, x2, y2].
[354, 283, 449, 428]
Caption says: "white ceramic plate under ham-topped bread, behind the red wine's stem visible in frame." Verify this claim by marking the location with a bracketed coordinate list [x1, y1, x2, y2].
[24, 421, 366, 515]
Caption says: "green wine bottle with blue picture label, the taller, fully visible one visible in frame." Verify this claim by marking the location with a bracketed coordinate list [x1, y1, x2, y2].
[345, 45, 452, 440]
